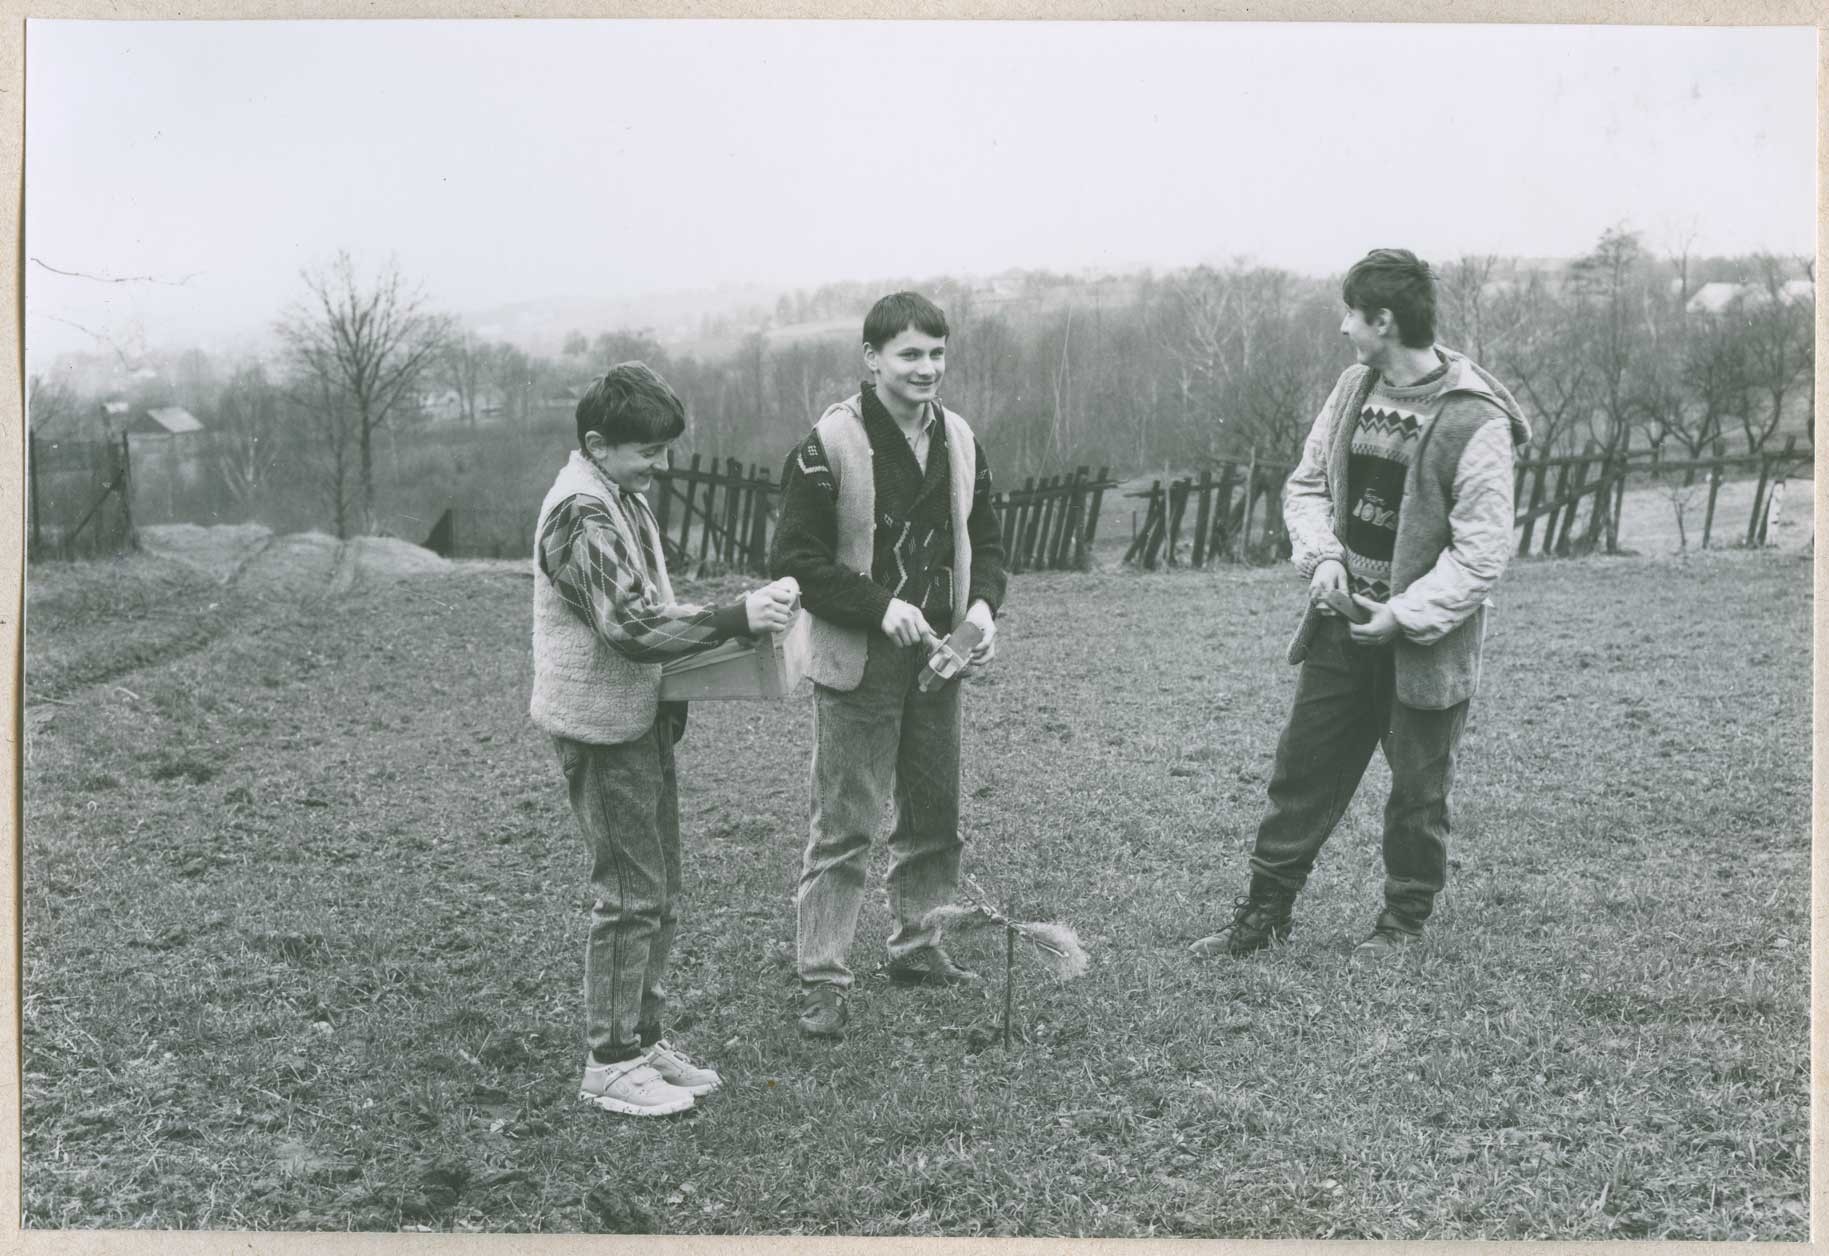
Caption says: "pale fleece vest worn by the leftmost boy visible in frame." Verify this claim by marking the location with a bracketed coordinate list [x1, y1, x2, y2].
[529, 450, 673, 746]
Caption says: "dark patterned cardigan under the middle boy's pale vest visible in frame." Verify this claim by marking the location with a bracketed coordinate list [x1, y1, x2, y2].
[770, 382, 1008, 633]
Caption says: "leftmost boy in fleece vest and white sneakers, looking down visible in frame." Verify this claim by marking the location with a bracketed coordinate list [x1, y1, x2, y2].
[530, 362, 796, 1117]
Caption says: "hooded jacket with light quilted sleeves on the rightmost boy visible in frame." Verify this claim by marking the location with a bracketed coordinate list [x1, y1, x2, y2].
[1284, 346, 1531, 709]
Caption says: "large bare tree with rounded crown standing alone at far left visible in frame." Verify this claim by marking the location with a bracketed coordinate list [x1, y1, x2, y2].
[278, 252, 450, 536]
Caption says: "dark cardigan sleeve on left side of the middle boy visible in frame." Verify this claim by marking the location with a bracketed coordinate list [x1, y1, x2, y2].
[768, 431, 889, 631]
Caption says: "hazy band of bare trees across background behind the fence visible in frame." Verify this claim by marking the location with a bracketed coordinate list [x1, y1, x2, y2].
[31, 227, 1814, 536]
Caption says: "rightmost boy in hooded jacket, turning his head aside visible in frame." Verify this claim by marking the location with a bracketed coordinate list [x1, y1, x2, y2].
[1193, 249, 1531, 963]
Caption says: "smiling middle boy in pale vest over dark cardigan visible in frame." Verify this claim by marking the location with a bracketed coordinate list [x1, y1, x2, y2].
[770, 293, 1004, 1038]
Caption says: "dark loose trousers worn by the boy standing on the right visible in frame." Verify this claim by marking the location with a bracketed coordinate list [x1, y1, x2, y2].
[1251, 618, 1467, 925]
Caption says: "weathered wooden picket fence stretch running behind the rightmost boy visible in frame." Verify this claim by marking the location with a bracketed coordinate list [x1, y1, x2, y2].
[1125, 437, 1813, 570]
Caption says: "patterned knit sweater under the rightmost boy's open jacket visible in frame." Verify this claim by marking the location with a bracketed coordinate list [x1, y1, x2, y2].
[1341, 366, 1449, 601]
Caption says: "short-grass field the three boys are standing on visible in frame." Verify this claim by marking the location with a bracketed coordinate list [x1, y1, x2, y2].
[24, 534, 1811, 1240]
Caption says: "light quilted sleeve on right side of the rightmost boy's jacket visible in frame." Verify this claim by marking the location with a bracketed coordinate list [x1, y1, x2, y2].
[1390, 415, 1513, 645]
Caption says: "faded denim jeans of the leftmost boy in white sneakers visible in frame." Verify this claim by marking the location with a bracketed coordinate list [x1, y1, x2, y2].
[552, 718, 680, 1062]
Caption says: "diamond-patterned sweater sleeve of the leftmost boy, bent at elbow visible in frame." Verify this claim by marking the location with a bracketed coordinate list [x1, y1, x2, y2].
[540, 497, 750, 664]
